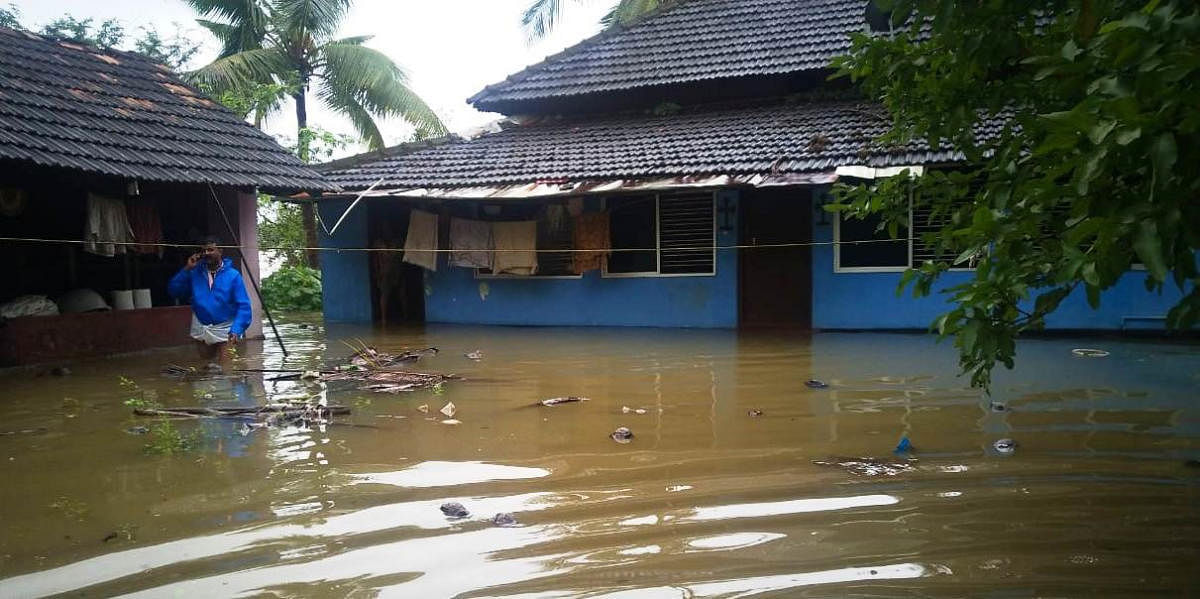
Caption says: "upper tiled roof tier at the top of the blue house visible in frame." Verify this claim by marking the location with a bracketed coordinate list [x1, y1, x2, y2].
[470, 0, 868, 109]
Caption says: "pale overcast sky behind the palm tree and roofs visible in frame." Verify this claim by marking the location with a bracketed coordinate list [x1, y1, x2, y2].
[9, 0, 611, 157]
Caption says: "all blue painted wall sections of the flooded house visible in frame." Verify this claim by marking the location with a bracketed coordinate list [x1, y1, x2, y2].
[320, 190, 1182, 330]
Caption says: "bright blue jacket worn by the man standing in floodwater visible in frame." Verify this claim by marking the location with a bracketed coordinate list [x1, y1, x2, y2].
[167, 258, 253, 337]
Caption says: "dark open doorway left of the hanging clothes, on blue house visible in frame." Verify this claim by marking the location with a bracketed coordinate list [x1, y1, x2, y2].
[366, 199, 425, 325]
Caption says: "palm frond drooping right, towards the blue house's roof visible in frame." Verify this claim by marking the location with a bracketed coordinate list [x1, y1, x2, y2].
[317, 43, 446, 143]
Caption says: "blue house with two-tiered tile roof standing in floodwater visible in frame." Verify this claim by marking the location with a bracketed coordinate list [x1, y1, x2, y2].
[319, 0, 1180, 330]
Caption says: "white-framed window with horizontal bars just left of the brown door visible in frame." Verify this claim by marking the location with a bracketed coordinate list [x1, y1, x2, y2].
[605, 192, 716, 276]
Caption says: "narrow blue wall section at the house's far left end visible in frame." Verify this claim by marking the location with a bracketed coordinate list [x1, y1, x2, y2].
[317, 199, 371, 323]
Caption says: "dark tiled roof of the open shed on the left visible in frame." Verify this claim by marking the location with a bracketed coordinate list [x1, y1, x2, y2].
[0, 28, 336, 193]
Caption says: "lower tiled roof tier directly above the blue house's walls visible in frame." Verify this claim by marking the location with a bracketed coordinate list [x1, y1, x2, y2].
[325, 100, 974, 190]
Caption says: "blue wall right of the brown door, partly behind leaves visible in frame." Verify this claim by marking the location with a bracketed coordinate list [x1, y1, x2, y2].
[812, 207, 1182, 330]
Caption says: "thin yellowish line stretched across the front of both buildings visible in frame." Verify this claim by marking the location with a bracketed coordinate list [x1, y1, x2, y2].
[0, 236, 917, 253]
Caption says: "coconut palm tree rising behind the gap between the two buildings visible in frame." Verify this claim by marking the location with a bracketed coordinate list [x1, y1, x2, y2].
[187, 0, 446, 265]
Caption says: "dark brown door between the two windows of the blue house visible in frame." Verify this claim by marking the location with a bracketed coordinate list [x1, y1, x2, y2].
[738, 187, 812, 330]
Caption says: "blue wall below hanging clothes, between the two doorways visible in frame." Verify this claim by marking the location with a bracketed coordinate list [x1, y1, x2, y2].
[425, 198, 738, 328]
